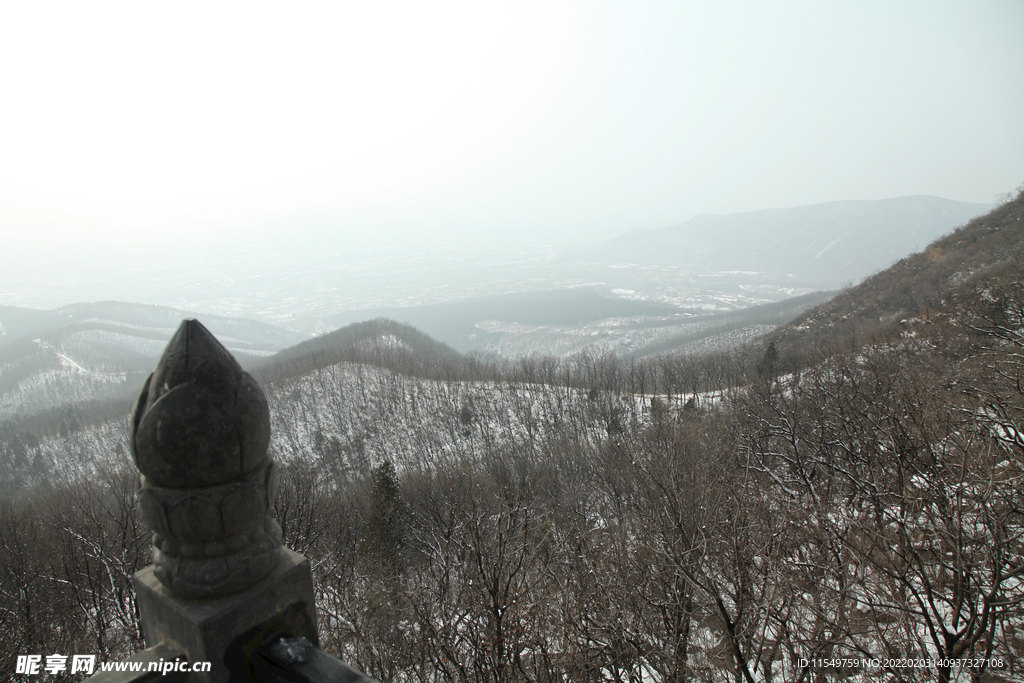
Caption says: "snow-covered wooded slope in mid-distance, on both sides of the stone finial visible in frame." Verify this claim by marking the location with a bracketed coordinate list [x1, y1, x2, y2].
[0, 362, 649, 497]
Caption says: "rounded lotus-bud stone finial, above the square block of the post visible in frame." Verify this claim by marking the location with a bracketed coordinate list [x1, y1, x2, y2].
[129, 318, 284, 599]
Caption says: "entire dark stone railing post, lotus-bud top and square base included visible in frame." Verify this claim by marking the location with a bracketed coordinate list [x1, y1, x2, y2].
[94, 319, 370, 683]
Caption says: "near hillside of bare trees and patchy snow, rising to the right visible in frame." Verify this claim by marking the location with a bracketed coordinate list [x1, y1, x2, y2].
[0, 189, 1024, 683]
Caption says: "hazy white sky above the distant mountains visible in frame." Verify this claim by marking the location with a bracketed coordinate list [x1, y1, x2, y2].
[0, 0, 1024, 244]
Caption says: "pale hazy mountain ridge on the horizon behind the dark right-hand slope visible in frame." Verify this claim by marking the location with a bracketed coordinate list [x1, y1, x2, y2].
[566, 196, 992, 288]
